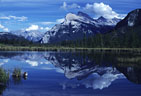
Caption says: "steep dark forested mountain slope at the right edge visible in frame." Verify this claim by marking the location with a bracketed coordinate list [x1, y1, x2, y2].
[87, 9, 141, 48]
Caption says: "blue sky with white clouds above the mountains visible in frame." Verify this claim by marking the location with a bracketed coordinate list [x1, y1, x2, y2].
[0, 0, 141, 32]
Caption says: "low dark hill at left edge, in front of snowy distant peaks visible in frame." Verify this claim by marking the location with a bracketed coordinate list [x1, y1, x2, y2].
[0, 32, 31, 45]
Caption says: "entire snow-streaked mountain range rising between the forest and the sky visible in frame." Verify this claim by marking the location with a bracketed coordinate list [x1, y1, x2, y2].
[0, 9, 141, 47]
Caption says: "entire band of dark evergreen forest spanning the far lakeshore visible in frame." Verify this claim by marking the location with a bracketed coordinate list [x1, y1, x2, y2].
[0, 26, 141, 48]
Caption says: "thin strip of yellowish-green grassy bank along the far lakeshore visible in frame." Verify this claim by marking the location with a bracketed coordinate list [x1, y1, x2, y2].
[0, 45, 141, 53]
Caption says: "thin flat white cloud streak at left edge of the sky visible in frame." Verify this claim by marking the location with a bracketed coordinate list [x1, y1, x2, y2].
[0, 15, 28, 21]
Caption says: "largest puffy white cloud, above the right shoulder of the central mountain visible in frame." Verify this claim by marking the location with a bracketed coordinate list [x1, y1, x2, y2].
[84, 2, 124, 19]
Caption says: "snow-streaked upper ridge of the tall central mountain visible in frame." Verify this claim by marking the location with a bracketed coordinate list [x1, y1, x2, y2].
[63, 12, 121, 28]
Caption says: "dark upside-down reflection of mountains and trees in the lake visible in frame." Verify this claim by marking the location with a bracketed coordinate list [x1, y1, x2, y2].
[0, 52, 141, 85]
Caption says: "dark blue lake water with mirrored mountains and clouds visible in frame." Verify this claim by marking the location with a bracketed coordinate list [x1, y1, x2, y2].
[0, 52, 141, 96]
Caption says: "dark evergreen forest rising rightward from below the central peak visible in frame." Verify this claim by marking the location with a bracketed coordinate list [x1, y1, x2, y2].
[56, 26, 141, 48]
